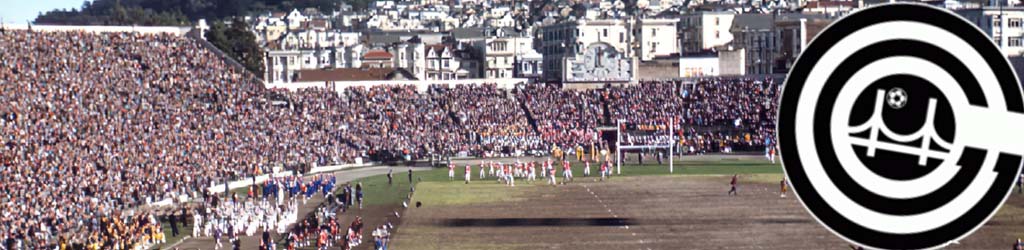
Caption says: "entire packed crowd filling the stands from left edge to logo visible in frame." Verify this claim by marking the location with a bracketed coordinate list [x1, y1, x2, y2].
[0, 31, 778, 249]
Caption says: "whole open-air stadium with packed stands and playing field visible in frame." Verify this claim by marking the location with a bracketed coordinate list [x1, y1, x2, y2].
[6, 1, 1024, 249]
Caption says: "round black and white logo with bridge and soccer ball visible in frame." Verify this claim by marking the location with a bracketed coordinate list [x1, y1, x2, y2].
[777, 4, 1024, 249]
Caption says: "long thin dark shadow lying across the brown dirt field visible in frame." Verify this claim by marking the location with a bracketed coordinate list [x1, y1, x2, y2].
[440, 218, 635, 227]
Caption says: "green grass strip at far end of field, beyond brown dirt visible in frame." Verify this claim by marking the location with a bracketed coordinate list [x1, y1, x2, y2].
[335, 158, 782, 249]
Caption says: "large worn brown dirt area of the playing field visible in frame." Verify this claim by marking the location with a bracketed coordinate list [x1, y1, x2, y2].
[393, 176, 1024, 249]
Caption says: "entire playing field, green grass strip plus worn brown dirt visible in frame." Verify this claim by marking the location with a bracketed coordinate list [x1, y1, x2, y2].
[165, 156, 1024, 250]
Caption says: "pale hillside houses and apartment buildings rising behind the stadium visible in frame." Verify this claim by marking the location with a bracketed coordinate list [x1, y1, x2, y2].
[197, 0, 1024, 84]
